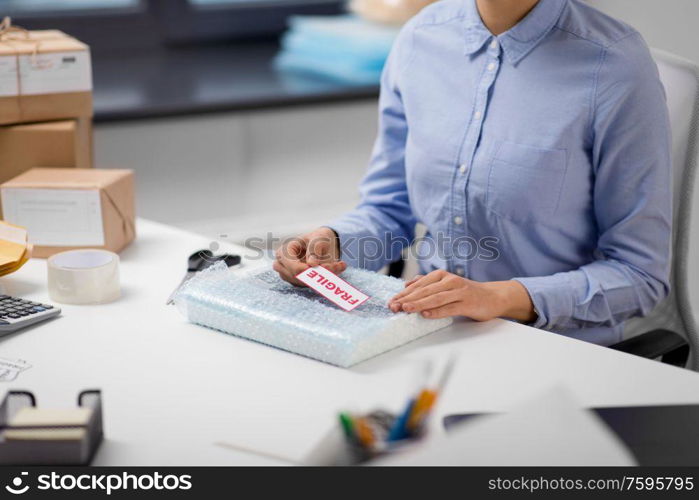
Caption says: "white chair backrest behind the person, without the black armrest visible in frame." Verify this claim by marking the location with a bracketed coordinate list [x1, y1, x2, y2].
[624, 50, 699, 370]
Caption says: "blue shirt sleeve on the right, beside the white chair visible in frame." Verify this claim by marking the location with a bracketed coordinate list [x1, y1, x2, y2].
[517, 33, 672, 330]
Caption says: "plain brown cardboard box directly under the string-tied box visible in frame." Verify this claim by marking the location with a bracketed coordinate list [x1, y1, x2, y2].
[0, 118, 92, 186]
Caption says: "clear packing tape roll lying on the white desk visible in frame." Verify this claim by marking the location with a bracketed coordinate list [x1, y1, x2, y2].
[47, 249, 121, 304]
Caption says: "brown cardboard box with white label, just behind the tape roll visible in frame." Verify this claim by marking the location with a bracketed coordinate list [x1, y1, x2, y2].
[0, 168, 136, 257]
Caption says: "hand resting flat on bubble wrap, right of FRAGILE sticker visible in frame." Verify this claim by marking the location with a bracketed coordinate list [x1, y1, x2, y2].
[388, 270, 536, 322]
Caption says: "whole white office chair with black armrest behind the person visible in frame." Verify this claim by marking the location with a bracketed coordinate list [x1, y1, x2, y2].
[388, 50, 699, 371]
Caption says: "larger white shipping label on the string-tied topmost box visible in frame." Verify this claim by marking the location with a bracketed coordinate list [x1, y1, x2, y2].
[15, 50, 92, 95]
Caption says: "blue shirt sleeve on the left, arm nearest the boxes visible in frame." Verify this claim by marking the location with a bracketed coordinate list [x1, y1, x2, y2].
[328, 22, 416, 270]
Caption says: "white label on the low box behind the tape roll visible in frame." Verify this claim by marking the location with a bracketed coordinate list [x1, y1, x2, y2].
[2, 188, 105, 247]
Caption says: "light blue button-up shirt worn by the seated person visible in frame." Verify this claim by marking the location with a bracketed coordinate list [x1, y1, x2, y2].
[329, 0, 672, 344]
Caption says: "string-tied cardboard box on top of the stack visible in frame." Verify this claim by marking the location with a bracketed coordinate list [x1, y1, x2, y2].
[0, 30, 92, 125]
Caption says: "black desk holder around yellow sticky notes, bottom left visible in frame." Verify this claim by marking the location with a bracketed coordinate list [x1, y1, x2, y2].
[0, 390, 103, 465]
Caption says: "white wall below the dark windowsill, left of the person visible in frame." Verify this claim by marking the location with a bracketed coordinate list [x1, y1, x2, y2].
[95, 99, 376, 241]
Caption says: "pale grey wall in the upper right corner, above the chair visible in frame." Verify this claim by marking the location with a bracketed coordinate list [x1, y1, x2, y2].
[588, 0, 699, 62]
